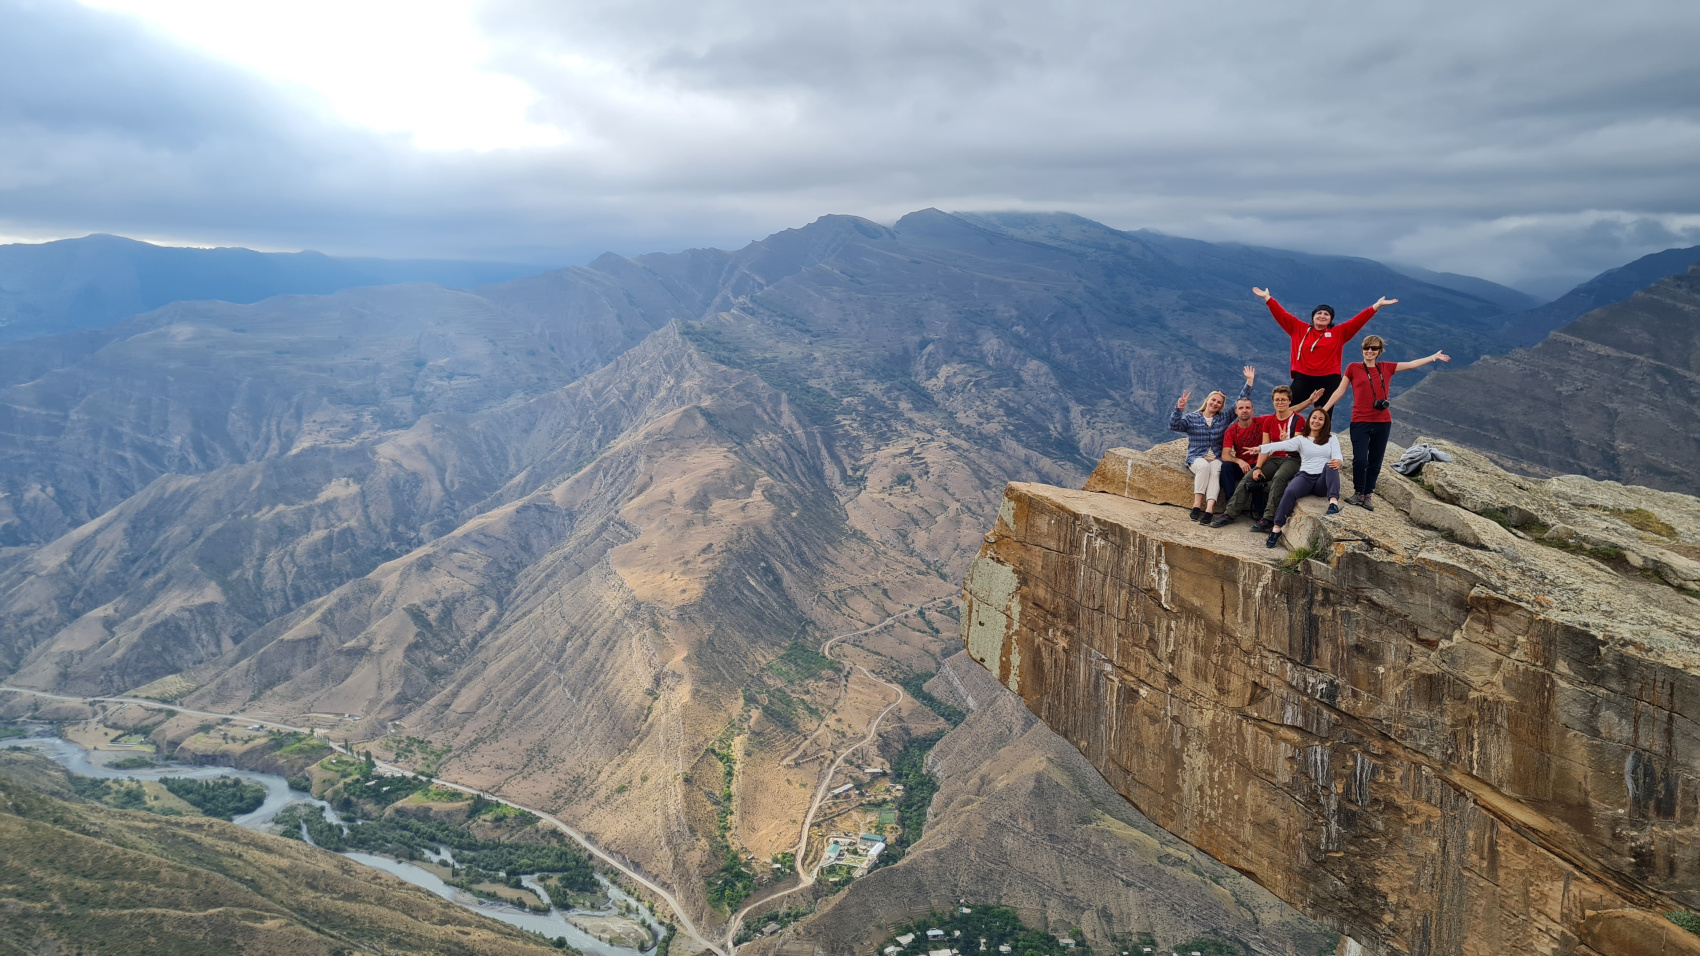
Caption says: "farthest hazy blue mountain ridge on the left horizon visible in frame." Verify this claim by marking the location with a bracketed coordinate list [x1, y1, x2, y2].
[0, 235, 537, 342]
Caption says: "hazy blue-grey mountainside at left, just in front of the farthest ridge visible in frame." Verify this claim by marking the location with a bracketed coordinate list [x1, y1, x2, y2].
[0, 269, 697, 546]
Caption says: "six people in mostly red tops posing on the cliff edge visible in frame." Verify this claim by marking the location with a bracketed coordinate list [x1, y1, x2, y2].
[1170, 289, 1452, 548]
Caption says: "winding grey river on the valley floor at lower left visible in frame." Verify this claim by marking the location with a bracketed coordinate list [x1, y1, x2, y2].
[7, 724, 663, 956]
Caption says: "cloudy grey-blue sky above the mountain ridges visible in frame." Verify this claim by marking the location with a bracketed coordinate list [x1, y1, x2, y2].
[0, 0, 1700, 296]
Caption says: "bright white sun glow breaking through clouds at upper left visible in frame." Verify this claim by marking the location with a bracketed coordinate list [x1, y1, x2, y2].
[82, 0, 563, 150]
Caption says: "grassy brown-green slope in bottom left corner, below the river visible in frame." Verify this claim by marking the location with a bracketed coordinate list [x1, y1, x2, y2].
[0, 754, 558, 956]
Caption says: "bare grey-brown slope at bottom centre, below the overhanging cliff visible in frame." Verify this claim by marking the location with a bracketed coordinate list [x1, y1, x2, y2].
[755, 652, 1331, 956]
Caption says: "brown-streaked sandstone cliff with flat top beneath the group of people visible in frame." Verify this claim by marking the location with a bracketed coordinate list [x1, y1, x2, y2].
[962, 449, 1700, 956]
